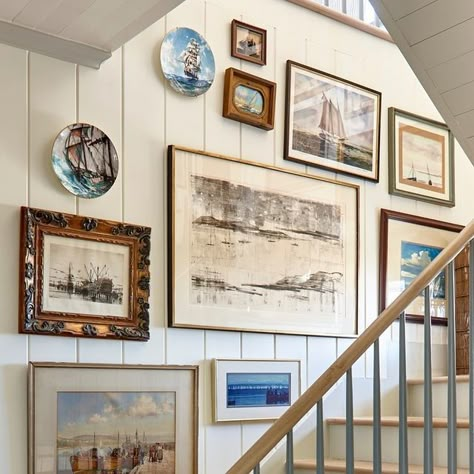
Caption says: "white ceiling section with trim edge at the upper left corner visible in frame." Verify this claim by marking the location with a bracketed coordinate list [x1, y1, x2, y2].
[0, 0, 184, 68]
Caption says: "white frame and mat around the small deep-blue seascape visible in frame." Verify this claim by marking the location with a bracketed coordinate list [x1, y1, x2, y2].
[214, 359, 301, 423]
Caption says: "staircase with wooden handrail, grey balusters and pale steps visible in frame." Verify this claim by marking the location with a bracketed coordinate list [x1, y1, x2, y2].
[227, 220, 474, 474]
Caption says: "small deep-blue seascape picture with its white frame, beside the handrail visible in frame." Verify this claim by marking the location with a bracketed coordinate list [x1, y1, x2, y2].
[214, 359, 301, 422]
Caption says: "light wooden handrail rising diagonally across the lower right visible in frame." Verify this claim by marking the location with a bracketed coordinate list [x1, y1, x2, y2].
[227, 220, 474, 474]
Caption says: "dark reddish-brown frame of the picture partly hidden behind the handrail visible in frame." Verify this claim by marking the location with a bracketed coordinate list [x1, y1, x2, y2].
[379, 209, 464, 325]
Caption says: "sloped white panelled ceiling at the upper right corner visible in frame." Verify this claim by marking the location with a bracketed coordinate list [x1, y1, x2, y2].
[370, 0, 474, 164]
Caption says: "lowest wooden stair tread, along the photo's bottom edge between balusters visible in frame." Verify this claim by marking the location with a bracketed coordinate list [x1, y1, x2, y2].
[294, 459, 469, 474]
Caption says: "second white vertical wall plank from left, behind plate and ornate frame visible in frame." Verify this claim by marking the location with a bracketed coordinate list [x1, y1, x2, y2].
[28, 53, 76, 361]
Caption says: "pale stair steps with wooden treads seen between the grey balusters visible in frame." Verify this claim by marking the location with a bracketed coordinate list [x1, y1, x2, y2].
[294, 375, 469, 474]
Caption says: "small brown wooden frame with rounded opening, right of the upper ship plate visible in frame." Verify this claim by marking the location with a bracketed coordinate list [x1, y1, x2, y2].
[222, 67, 277, 130]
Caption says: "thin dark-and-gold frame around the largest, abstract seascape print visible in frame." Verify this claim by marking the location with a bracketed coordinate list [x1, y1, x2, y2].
[167, 145, 360, 338]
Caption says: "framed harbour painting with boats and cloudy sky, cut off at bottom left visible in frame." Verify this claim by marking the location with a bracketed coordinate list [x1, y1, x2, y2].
[28, 362, 198, 474]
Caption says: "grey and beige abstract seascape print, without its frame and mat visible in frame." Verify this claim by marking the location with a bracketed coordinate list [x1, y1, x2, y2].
[190, 175, 346, 316]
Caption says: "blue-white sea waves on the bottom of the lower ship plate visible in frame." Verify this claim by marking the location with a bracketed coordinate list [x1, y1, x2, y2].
[52, 154, 114, 199]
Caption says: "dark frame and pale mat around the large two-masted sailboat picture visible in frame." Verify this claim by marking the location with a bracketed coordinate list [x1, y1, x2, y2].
[284, 60, 382, 183]
